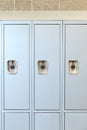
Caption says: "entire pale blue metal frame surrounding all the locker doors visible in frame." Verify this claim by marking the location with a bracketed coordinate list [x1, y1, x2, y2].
[0, 20, 87, 130]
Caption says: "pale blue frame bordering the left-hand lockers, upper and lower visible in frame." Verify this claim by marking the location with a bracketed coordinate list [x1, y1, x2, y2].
[1, 20, 32, 130]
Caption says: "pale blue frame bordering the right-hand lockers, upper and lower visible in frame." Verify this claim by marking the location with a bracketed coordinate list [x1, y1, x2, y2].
[62, 20, 87, 130]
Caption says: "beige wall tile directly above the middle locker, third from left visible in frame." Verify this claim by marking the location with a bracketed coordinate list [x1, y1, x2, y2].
[33, 0, 59, 10]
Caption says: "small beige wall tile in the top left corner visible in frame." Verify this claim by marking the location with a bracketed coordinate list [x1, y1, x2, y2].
[0, 0, 14, 11]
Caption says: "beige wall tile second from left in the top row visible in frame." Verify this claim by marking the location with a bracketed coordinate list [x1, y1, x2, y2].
[15, 0, 31, 11]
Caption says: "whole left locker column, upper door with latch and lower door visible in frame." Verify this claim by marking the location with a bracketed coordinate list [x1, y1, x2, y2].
[1, 21, 31, 130]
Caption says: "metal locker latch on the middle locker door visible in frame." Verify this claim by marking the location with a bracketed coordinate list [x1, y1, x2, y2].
[37, 60, 48, 74]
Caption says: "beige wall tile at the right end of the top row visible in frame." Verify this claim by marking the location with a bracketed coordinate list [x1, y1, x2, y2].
[60, 0, 87, 10]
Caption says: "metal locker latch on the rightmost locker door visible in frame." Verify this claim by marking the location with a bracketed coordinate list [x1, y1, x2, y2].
[68, 60, 79, 74]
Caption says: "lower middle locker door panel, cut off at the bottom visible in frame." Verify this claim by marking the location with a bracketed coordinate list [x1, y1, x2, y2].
[35, 113, 59, 130]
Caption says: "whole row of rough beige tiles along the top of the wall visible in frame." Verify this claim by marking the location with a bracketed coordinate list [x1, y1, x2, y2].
[0, 0, 87, 11]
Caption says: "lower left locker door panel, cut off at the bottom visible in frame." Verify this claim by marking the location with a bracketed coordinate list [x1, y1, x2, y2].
[5, 113, 30, 130]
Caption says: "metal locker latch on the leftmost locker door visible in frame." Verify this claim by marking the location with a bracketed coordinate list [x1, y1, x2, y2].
[7, 60, 18, 74]
